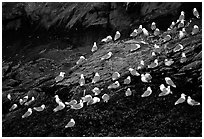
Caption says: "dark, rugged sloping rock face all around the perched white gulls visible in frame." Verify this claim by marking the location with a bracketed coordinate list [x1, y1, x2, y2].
[2, 3, 202, 137]
